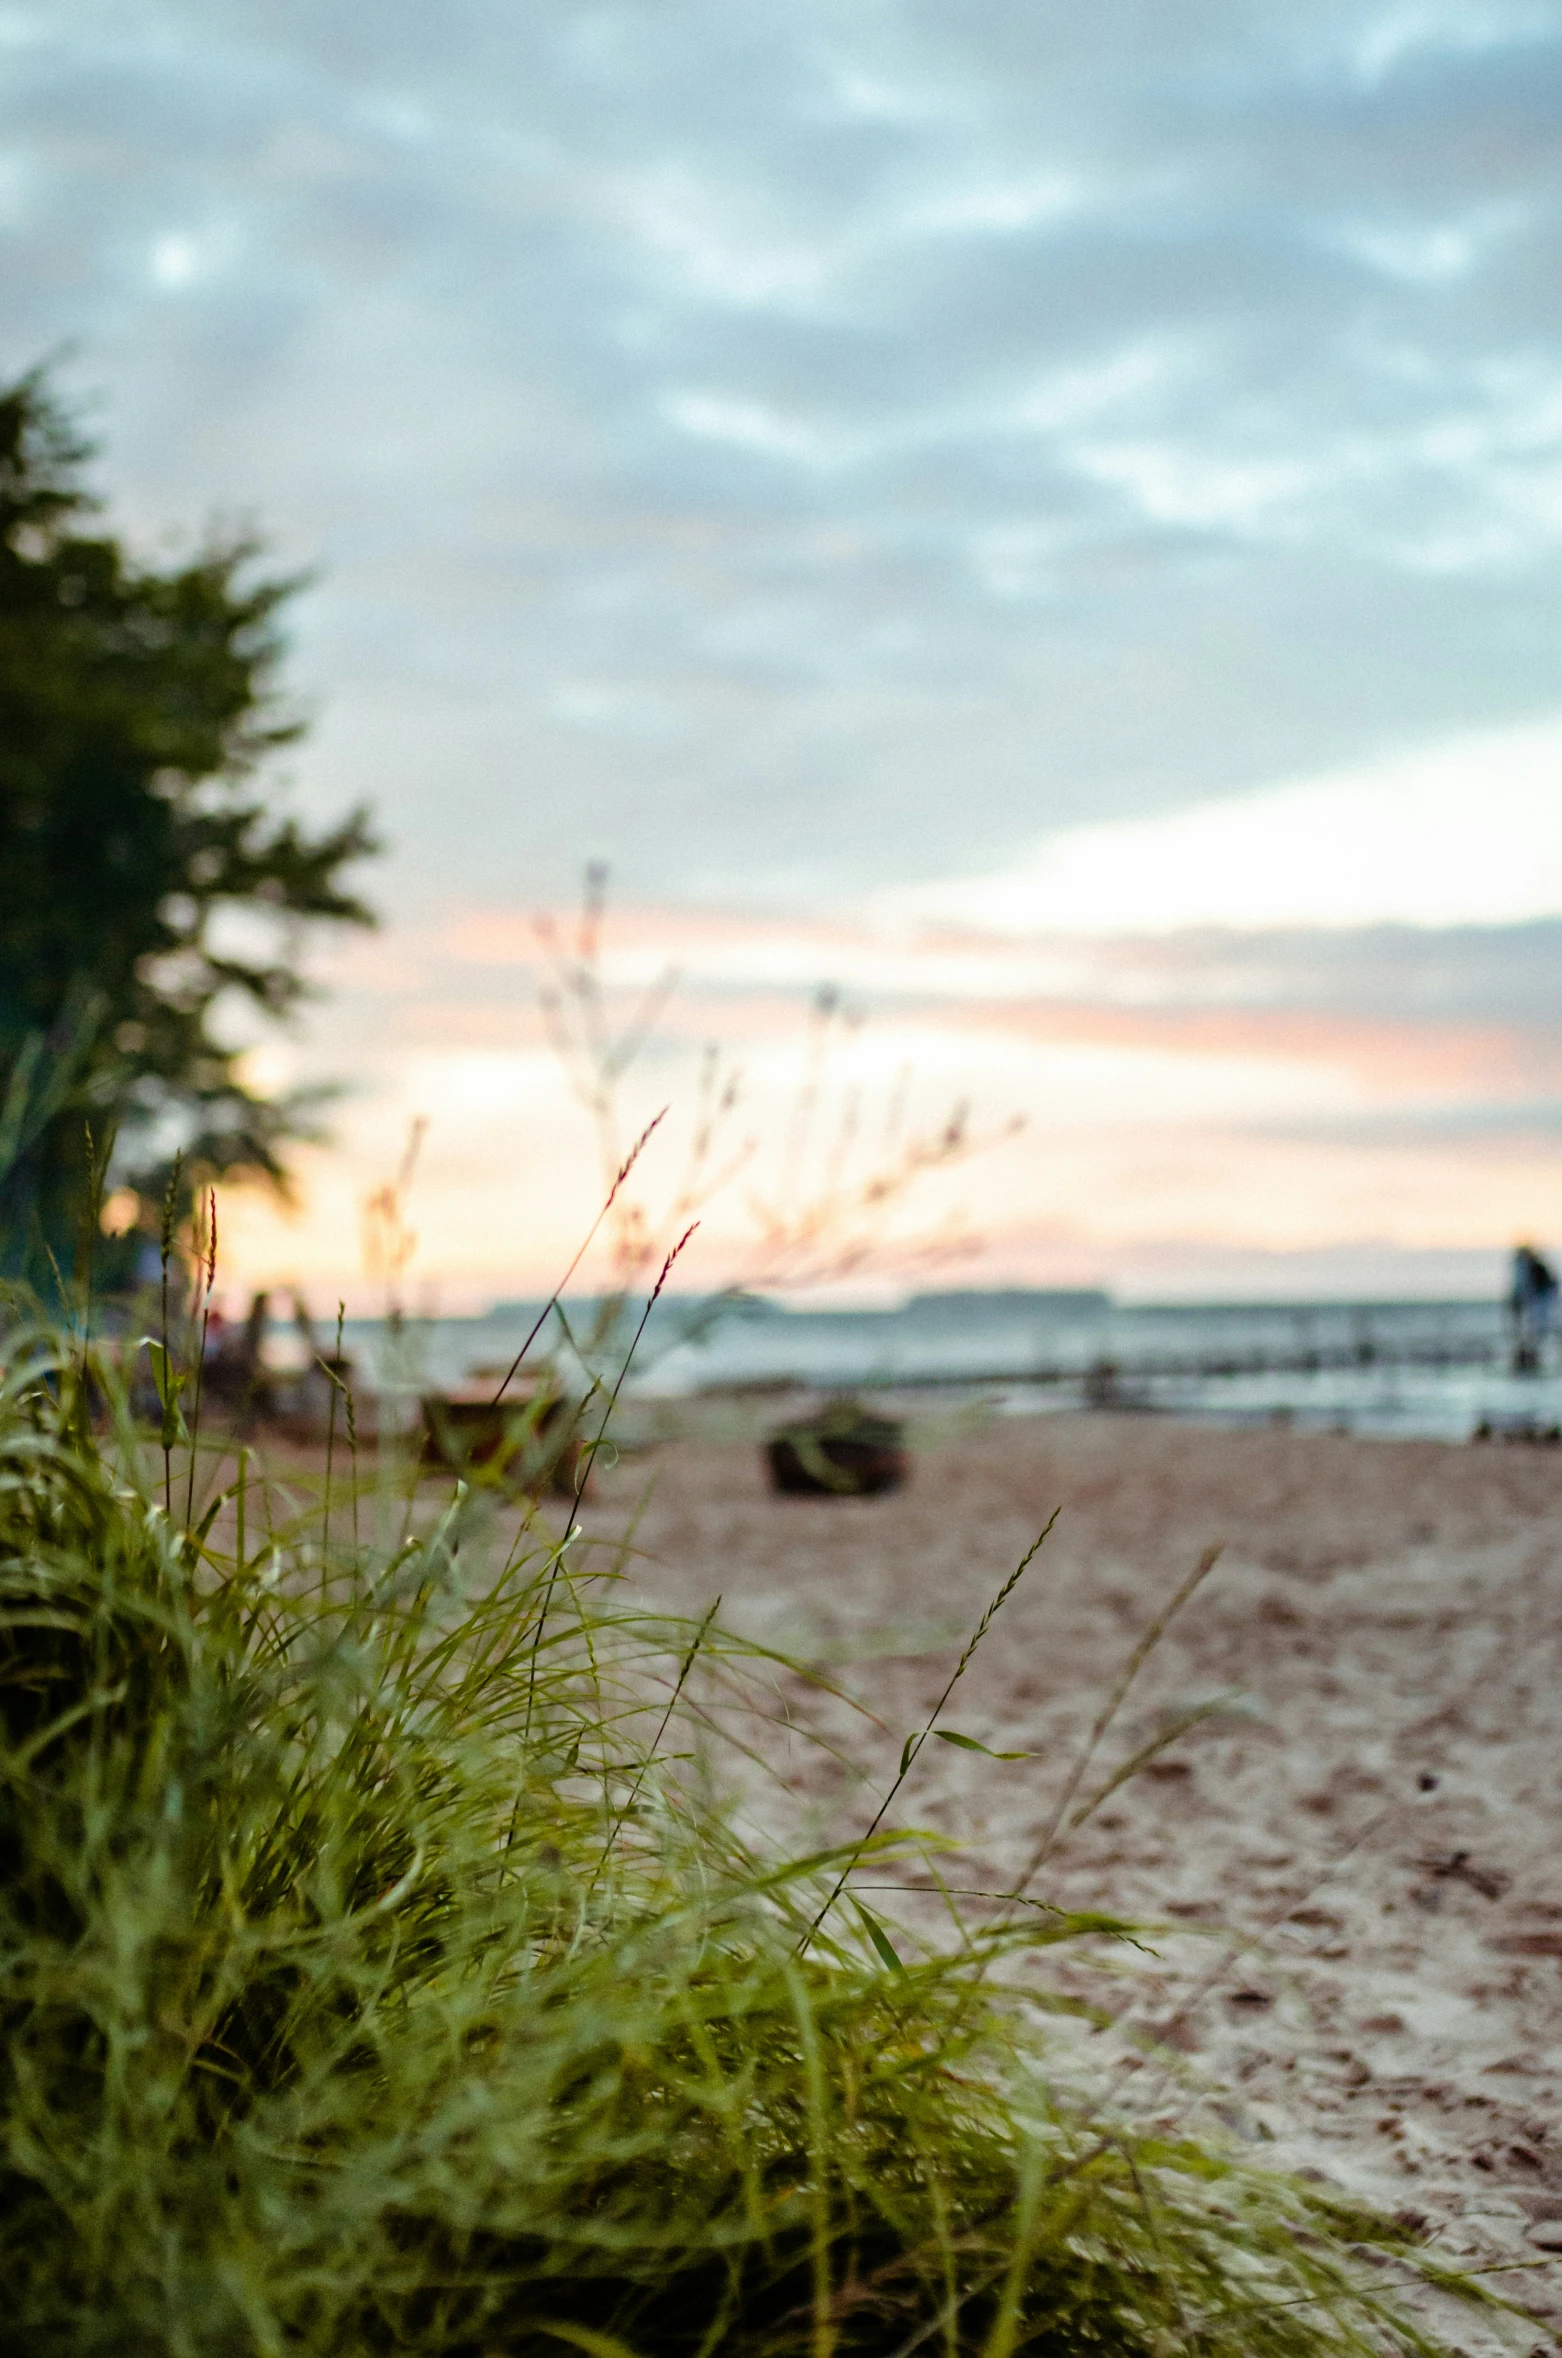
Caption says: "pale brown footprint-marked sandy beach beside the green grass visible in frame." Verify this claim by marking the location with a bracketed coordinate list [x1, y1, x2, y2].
[575, 1417, 1562, 2327]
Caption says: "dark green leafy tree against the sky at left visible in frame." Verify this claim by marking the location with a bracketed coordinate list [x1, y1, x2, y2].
[0, 373, 378, 1278]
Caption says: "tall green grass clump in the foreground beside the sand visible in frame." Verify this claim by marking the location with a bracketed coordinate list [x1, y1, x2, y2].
[0, 1325, 1519, 2358]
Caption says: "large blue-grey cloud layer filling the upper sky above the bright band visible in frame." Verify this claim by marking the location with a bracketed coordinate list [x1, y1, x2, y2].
[0, 0, 1562, 908]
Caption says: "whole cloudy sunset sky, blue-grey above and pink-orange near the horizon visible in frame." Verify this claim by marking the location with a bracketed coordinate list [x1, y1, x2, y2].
[0, 0, 1562, 1306]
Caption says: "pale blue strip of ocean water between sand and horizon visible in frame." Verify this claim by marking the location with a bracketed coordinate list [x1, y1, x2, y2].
[347, 1290, 1562, 1441]
